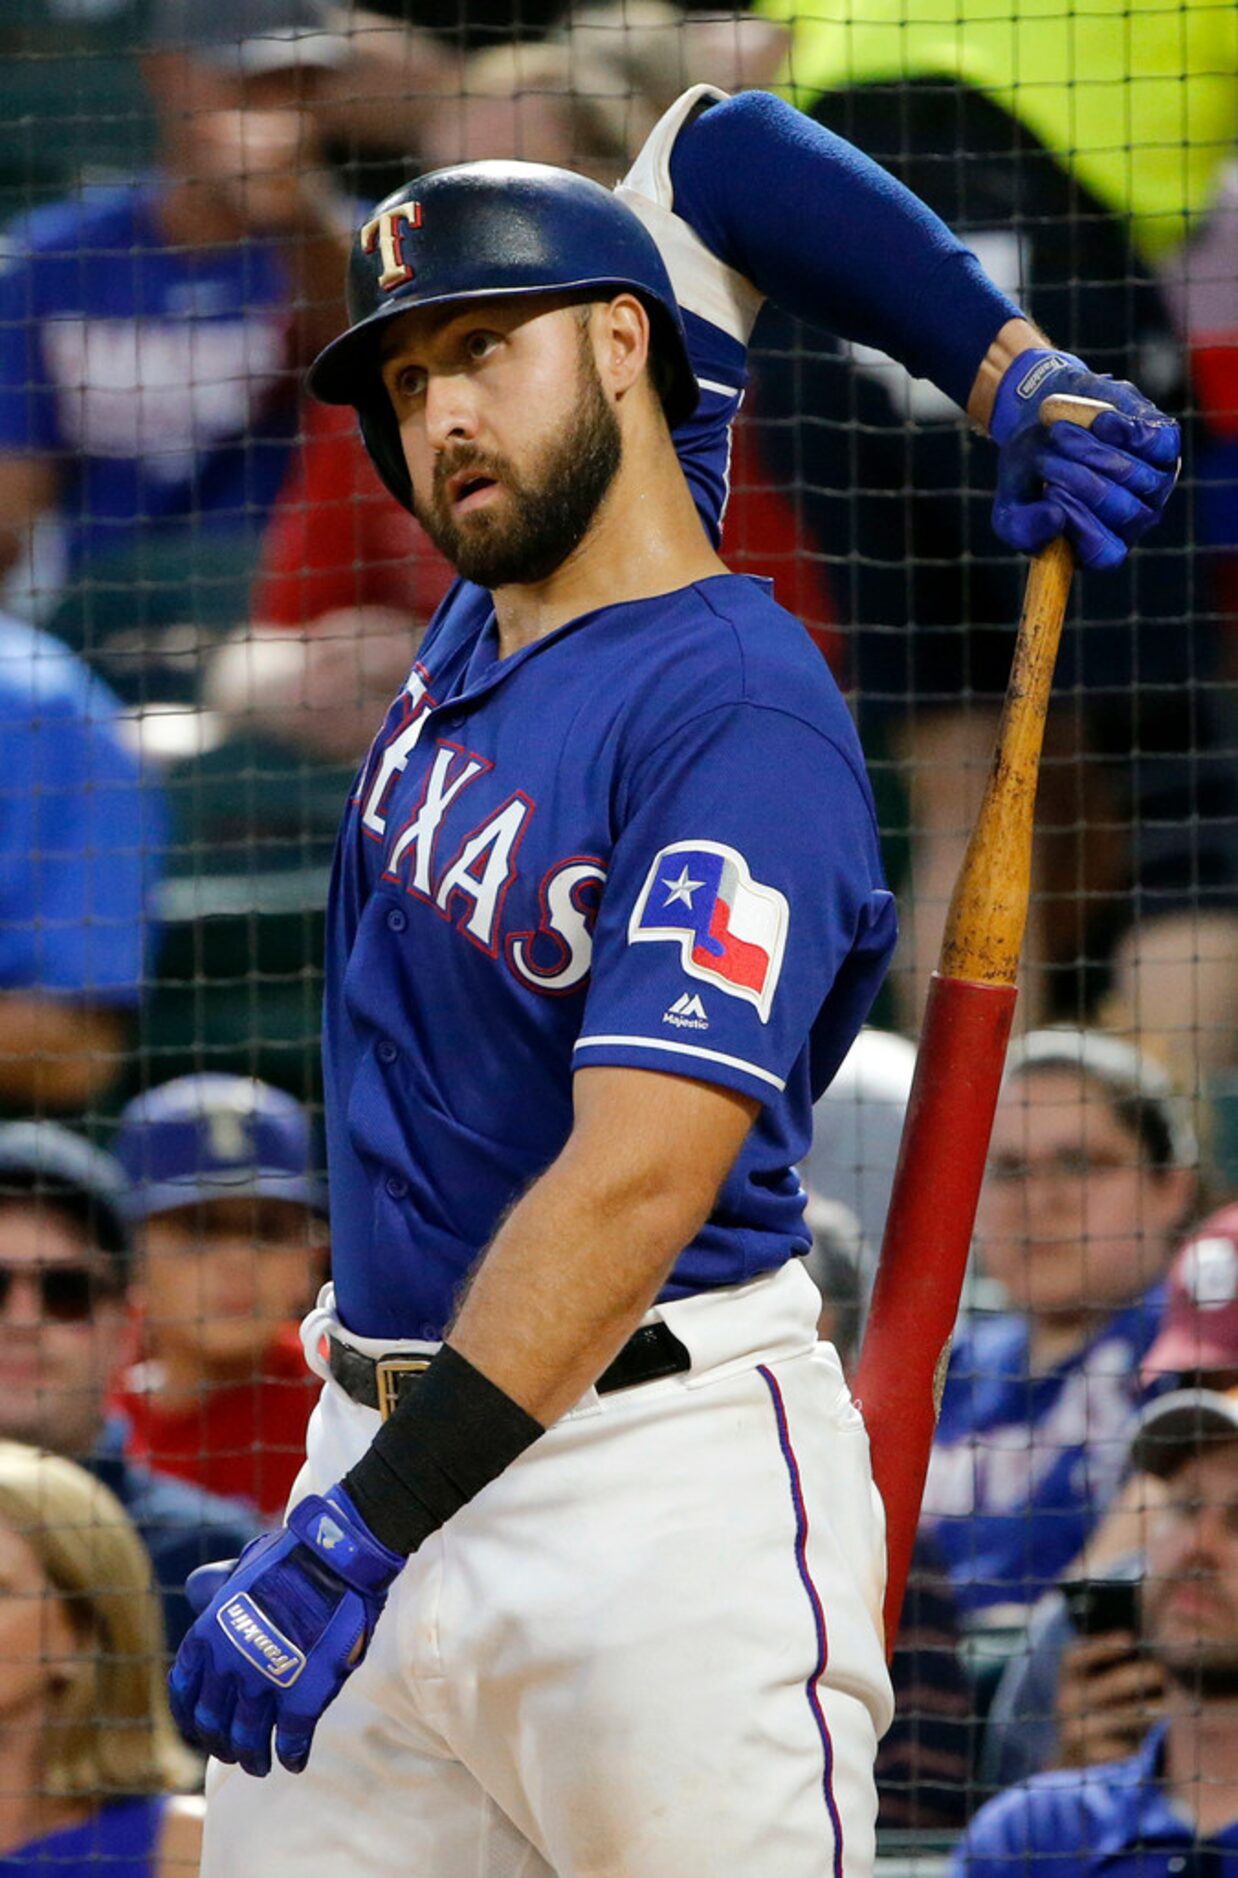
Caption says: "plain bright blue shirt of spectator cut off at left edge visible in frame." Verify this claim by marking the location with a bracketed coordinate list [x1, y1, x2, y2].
[0, 616, 167, 1005]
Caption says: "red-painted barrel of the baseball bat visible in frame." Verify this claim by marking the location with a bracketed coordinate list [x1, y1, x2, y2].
[855, 973, 1018, 1649]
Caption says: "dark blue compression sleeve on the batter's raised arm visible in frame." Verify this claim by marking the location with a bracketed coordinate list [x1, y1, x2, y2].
[671, 92, 1022, 406]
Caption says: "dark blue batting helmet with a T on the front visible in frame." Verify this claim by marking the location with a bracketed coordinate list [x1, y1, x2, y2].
[310, 162, 701, 509]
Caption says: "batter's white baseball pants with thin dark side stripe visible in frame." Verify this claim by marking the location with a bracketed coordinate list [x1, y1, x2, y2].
[201, 1262, 892, 1878]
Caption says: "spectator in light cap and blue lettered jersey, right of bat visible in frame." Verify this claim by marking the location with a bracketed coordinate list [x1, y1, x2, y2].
[924, 1029, 1197, 1623]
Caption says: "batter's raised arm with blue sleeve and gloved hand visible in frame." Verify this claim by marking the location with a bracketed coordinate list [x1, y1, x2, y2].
[620, 86, 1180, 567]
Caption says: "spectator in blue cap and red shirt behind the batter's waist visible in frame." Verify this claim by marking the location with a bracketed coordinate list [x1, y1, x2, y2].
[115, 1074, 327, 1519]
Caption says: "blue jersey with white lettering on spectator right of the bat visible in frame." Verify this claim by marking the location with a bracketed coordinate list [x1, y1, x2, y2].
[924, 1285, 1165, 1611]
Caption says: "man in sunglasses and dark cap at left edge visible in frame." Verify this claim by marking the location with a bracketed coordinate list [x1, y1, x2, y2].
[0, 1121, 255, 1649]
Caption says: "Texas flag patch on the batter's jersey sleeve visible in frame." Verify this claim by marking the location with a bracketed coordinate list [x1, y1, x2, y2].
[627, 841, 791, 1024]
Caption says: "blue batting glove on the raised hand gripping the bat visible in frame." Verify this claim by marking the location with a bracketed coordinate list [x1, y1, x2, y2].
[988, 349, 1182, 567]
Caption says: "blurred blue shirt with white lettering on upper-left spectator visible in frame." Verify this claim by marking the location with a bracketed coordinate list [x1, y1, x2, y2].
[0, 186, 297, 565]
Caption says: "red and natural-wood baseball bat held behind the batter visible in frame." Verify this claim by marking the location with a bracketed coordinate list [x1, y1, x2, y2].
[855, 396, 1110, 1655]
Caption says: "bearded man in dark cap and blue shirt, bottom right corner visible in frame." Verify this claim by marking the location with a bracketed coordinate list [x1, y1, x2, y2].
[951, 1390, 1238, 1878]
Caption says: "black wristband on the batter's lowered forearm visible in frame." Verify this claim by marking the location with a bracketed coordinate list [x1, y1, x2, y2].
[342, 1343, 545, 1553]
